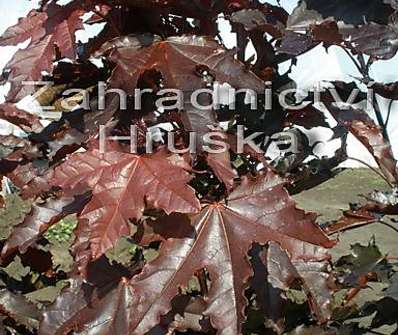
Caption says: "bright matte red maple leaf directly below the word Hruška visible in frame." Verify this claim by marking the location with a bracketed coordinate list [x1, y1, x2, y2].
[51, 149, 200, 258]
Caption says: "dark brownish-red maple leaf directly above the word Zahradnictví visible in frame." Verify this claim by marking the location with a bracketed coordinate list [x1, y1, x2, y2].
[109, 36, 264, 93]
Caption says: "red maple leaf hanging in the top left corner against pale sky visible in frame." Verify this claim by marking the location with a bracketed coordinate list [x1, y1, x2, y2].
[0, 2, 85, 101]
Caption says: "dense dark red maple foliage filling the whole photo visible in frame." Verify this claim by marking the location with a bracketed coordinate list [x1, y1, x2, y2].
[0, 0, 398, 335]
